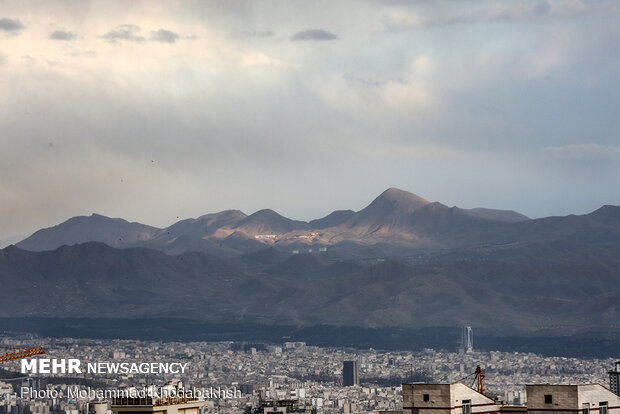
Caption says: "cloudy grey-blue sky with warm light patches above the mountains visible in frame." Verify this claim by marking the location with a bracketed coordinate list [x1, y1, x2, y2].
[0, 0, 620, 241]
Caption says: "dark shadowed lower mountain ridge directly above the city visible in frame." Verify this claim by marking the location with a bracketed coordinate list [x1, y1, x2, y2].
[0, 242, 620, 336]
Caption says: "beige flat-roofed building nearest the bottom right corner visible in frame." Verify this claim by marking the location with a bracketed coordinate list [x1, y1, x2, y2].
[525, 384, 620, 414]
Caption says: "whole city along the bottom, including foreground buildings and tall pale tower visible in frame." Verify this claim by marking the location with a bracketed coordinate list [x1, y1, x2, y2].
[0, 336, 620, 414]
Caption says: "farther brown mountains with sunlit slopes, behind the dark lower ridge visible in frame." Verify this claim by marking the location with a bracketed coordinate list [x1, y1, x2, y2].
[18, 188, 620, 259]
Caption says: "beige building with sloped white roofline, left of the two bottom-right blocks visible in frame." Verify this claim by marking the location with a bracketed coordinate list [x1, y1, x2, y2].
[403, 382, 500, 414]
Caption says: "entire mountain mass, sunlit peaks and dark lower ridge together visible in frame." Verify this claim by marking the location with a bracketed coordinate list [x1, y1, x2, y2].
[0, 188, 620, 341]
